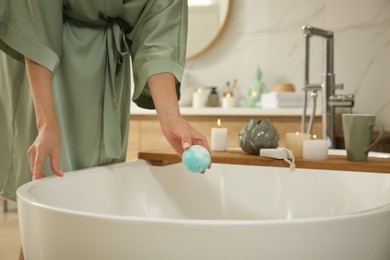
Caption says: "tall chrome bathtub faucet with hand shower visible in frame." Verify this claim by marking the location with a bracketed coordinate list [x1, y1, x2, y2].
[301, 25, 354, 148]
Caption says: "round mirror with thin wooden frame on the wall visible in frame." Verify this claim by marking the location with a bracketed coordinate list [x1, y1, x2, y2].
[187, 0, 231, 60]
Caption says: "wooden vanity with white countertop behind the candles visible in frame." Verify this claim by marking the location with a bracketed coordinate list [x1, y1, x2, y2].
[127, 104, 322, 160]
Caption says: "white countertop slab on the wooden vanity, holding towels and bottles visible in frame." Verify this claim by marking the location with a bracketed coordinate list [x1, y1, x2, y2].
[130, 103, 320, 116]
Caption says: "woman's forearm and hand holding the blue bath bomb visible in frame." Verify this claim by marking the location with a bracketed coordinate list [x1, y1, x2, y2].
[148, 73, 210, 159]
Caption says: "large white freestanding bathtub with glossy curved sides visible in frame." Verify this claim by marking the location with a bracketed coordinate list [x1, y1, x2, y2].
[17, 160, 390, 260]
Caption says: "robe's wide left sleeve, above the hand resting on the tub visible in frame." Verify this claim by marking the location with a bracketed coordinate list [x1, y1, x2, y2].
[0, 0, 63, 71]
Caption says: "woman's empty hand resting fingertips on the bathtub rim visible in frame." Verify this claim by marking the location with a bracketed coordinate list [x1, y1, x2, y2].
[27, 126, 63, 180]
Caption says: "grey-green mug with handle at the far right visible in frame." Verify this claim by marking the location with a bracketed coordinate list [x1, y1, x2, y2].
[342, 114, 384, 162]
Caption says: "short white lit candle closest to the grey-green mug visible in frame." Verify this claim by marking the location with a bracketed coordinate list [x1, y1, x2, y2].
[303, 135, 328, 160]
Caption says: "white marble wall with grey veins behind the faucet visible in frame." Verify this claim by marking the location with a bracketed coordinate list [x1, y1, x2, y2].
[181, 0, 390, 131]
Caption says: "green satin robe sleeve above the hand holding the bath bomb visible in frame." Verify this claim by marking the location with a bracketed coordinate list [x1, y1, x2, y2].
[129, 0, 188, 109]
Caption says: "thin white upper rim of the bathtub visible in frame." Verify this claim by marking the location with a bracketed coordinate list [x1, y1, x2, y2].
[16, 160, 390, 226]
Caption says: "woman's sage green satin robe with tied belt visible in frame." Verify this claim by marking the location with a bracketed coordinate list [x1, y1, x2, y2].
[0, 0, 187, 200]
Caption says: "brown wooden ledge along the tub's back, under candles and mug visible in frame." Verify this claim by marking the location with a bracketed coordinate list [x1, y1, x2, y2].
[138, 149, 390, 173]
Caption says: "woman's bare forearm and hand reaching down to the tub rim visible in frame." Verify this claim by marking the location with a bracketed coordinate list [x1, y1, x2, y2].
[25, 58, 63, 179]
